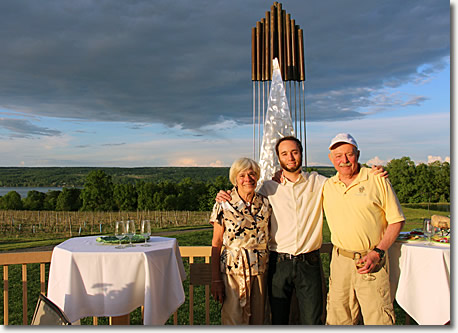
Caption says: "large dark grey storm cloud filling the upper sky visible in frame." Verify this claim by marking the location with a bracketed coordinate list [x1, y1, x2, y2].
[0, 0, 450, 129]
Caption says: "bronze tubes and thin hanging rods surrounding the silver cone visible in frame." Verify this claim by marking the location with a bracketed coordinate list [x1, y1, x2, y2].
[251, 2, 307, 166]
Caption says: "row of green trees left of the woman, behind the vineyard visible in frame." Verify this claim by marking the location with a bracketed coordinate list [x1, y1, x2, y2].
[0, 170, 232, 211]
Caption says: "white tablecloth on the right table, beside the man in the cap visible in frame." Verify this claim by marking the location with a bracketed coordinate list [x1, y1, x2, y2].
[388, 242, 450, 325]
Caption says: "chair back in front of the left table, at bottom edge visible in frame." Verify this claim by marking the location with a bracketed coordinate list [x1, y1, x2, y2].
[30, 294, 71, 325]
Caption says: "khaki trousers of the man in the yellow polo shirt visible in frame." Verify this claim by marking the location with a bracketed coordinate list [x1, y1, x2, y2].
[326, 248, 395, 325]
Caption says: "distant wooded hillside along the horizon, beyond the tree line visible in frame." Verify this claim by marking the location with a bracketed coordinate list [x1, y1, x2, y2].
[0, 167, 335, 187]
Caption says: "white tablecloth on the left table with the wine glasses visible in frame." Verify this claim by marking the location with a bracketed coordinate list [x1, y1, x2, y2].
[48, 236, 186, 325]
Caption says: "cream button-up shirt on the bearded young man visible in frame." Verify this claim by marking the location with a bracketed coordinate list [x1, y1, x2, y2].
[259, 172, 328, 255]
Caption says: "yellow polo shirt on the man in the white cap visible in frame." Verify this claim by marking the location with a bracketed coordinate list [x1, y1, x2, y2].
[323, 167, 405, 251]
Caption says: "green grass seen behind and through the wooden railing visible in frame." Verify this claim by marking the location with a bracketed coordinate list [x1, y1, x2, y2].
[0, 208, 449, 325]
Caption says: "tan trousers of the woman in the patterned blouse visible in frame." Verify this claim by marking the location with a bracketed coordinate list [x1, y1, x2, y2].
[221, 273, 267, 325]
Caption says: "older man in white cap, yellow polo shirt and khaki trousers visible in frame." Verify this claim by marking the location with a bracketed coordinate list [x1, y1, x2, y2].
[323, 133, 405, 325]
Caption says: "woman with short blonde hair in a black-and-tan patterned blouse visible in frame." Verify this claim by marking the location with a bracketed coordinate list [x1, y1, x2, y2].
[210, 157, 272, 325]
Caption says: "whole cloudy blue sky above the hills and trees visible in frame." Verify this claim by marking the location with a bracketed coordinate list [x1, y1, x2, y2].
[0, 0, 450, 167]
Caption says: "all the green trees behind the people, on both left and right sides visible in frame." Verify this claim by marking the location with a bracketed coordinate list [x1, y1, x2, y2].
[0, 157, 450, 211]
